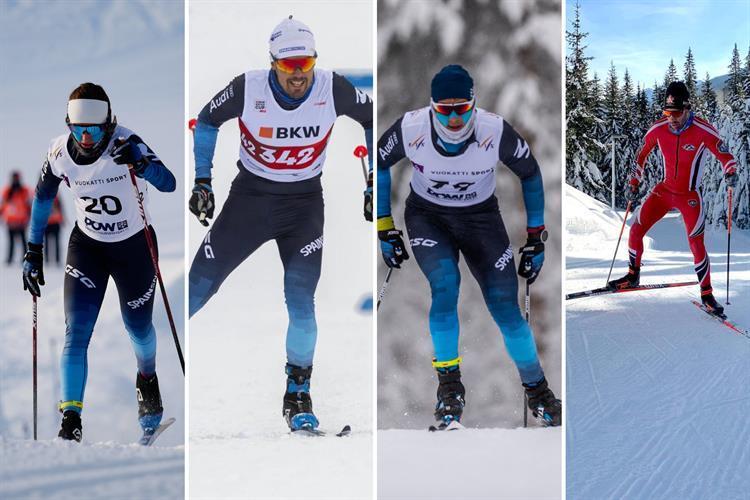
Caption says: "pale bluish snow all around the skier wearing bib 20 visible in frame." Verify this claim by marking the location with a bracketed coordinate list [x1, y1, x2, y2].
[0, 1, 185, 498]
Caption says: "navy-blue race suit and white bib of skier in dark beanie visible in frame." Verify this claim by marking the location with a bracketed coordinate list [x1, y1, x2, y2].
[377, 108, 544, 385]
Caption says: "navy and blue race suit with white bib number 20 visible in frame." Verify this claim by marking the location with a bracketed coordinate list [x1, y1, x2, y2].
[29, 125, 176, 413]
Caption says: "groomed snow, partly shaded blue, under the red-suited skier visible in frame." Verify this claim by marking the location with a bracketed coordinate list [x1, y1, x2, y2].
[565, 186, 750, 499]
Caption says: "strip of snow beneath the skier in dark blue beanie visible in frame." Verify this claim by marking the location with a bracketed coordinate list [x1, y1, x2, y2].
[378, 427, 562, 500]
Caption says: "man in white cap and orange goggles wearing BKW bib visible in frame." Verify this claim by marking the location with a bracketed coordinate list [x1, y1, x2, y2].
[189, 16, 372, 431]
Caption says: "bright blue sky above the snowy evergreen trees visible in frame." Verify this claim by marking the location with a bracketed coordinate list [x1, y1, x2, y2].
[566, 0, 750, 87]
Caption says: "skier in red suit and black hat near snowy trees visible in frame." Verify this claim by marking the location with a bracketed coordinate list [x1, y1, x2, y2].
[609, 82, 737, 314]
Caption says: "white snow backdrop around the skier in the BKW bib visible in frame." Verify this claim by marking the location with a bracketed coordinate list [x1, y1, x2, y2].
[188, 2, 374, 499]
